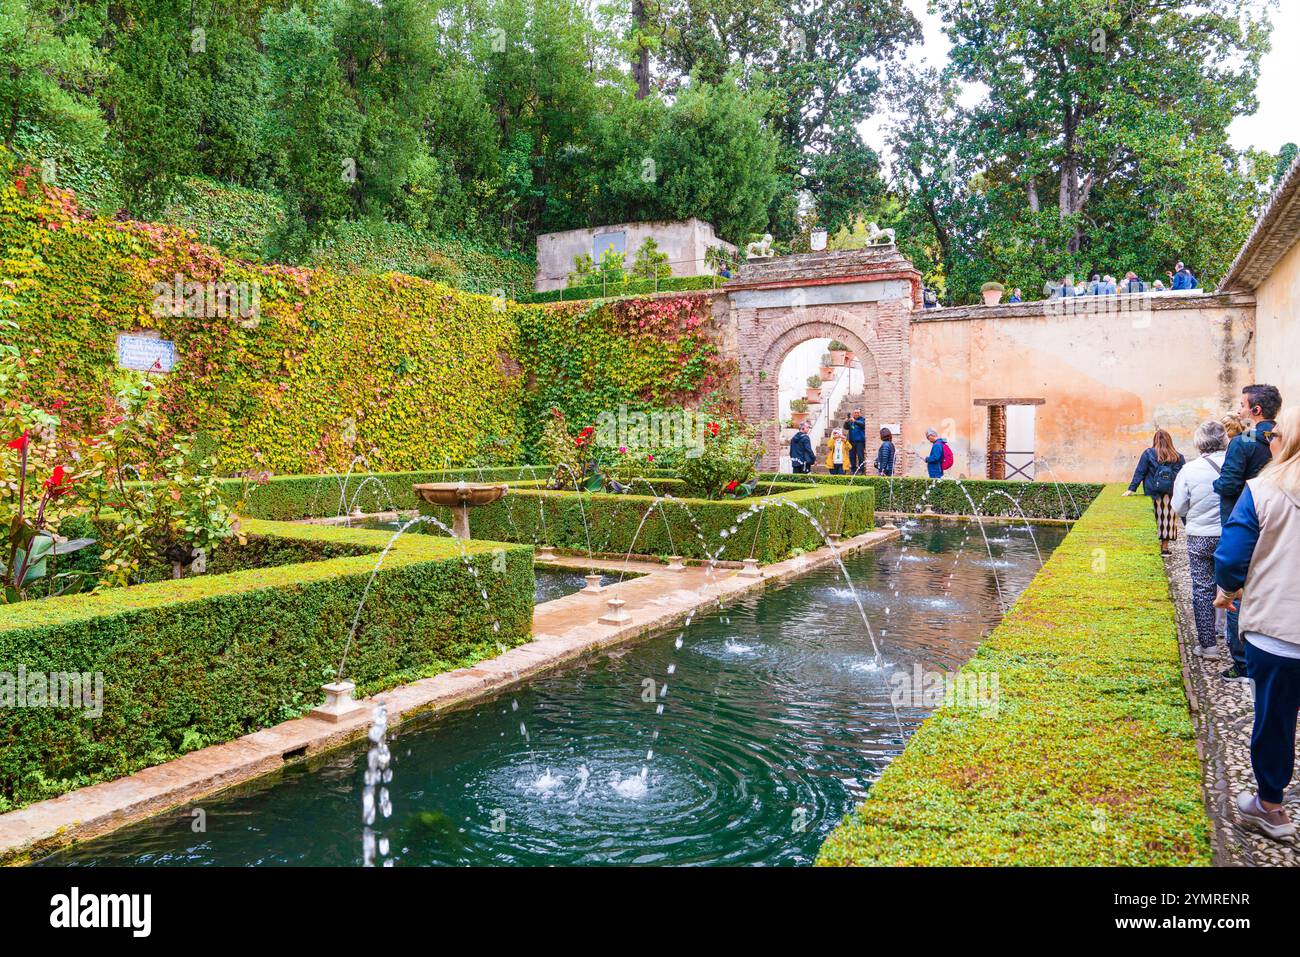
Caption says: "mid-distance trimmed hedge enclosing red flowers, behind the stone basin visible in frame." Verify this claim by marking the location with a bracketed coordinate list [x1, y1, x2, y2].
[420, 476, 875, 564]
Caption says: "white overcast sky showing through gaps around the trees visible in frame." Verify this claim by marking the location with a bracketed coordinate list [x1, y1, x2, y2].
[861, 0, 1300, 152]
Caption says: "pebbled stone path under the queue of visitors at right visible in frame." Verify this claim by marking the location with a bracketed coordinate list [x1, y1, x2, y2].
[1165, 538, 1300, 866]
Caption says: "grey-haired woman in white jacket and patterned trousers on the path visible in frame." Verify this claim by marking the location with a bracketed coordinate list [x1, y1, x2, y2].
[1170, 421, 1227, 658]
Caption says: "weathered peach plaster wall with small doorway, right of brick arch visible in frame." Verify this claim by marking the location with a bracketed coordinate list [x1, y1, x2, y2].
[904, 295, 1255, 481]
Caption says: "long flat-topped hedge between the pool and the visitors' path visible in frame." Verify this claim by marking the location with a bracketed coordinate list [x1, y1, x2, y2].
[818, 485, 1210, 866]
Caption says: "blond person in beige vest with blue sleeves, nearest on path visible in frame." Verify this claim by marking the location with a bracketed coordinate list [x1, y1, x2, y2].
[1214, 408, 1300, 840]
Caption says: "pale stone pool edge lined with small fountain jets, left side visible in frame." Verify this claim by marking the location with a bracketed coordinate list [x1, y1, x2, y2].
[0, 528, 901, 866]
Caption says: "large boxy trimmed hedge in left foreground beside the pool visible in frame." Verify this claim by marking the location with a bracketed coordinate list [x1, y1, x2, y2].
[0, 521, 533, 810]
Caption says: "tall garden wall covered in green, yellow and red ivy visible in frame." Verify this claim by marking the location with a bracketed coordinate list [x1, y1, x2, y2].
[0, 155, 729, 473]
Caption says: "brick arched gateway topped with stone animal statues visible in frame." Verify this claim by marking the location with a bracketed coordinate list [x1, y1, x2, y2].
[725, 244, 922, 468]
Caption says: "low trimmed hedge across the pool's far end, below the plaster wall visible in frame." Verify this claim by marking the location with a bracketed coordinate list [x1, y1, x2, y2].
[763, 472, 1102, 519]
